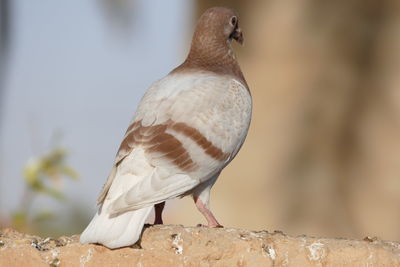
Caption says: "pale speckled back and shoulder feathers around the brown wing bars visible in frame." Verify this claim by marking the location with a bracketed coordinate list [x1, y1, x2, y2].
[134, 72, 252, 175]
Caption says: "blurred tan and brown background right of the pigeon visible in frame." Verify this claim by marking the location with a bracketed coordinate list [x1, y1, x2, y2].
[0, 0, 400, 243]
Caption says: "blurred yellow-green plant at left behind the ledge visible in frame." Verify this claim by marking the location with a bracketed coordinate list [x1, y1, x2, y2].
[12, 147, 78, 232]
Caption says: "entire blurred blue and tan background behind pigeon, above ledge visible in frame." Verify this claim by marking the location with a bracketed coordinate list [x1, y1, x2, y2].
[0, 0, 400, 243]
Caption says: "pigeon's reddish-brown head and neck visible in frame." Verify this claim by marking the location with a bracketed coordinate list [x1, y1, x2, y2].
[172, 7, 247, 86]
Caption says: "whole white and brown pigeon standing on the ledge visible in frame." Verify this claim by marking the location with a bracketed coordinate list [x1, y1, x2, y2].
[80, 7, 252, 249]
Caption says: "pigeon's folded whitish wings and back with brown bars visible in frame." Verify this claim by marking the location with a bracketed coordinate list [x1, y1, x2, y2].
[99, 71, 251, 213]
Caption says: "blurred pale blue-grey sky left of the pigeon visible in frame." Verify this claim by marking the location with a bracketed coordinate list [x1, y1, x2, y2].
[0, 0, 193, 217]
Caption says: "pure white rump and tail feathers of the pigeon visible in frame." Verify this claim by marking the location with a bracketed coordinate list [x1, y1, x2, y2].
[80, 148, 154, 248]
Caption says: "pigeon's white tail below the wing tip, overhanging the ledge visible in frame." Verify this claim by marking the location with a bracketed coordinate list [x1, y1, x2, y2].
[80, 206, 153, 248]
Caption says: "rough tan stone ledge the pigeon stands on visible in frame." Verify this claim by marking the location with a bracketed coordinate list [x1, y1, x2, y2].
[0, 225, 400, 267]
